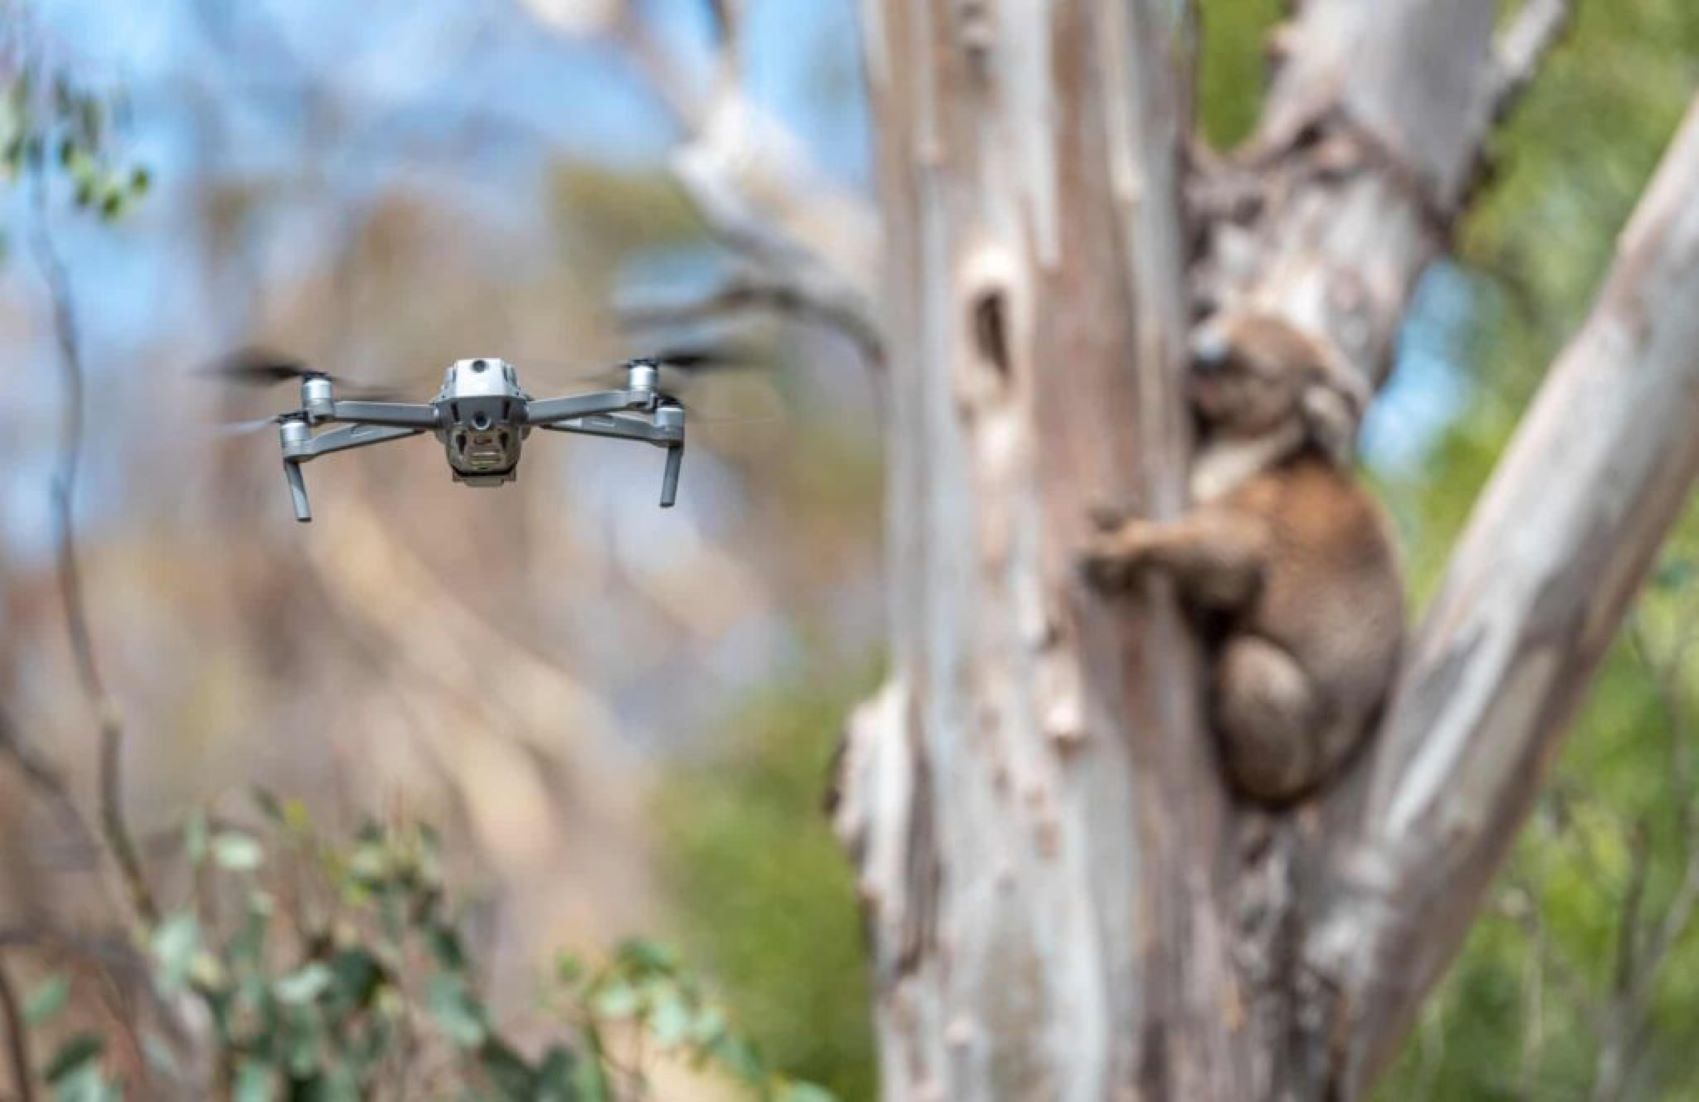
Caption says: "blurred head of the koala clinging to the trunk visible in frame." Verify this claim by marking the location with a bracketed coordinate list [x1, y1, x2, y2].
[1186, 314, 1369, 465]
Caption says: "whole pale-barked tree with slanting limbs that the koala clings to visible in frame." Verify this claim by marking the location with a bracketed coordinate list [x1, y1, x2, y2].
[801, 0, 1699, 1099]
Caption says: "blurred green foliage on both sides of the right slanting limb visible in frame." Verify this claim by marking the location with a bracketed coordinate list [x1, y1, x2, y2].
[1381, 0, 1699, 1099]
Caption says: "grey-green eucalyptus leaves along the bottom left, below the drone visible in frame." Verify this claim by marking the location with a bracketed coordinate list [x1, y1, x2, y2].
[16, 795, 831, 1102]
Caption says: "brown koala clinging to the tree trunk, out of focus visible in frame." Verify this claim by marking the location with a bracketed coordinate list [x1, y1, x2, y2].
[1084, 316, 1403, 805]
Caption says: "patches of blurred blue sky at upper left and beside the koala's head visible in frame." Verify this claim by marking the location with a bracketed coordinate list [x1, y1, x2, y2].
[0, 0, 1468, 555]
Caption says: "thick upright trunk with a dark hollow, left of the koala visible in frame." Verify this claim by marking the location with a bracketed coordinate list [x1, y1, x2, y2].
[839, 0, 1235, 1099]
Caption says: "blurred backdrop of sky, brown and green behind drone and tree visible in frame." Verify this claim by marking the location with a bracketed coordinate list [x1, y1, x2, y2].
[0, 0, 1699, 1099]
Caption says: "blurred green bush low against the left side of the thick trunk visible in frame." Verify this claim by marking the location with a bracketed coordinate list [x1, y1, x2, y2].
[658, 678, 877, 1099]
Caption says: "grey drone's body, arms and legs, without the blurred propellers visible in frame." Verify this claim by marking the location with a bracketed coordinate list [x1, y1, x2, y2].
[277, 358, 685, 521]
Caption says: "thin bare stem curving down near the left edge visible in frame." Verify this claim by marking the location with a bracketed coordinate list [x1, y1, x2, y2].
[31, 180, 160, 925]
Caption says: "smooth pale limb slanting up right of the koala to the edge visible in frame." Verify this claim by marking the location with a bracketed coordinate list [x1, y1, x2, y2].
[1307, 102, 1699, 1094]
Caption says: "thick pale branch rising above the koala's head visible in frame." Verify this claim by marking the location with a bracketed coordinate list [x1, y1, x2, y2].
[1194, 0, 1568, 384]
